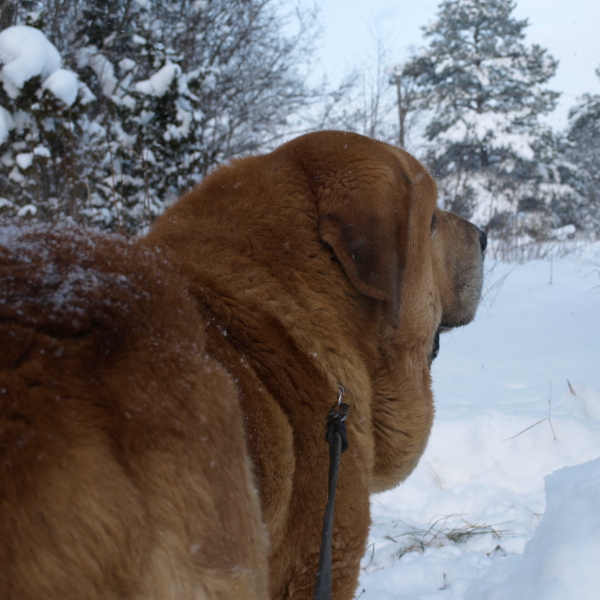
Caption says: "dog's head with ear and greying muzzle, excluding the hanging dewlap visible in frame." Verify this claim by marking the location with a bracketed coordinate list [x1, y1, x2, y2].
[283, 131, 486, 346]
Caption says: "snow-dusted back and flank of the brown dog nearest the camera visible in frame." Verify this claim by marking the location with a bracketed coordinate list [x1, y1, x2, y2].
[0, 225, 267, 600]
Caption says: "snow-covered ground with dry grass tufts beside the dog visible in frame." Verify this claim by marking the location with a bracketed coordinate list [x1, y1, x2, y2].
[356, 244, 600, 600]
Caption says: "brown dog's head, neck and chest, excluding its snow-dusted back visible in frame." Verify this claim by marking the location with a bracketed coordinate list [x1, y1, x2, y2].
[146, 132, 483, 599]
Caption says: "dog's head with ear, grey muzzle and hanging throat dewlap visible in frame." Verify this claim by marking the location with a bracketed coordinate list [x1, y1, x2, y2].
[283, 132, 486, 491]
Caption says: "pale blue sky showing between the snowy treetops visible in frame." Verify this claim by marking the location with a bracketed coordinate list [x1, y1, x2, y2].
[314, 0, 600, 127]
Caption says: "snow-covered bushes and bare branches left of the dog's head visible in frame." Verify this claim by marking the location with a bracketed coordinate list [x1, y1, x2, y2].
[0, 0, 313, 233]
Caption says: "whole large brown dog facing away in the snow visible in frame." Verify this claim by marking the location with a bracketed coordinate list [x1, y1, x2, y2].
[0, 132, 485, 600]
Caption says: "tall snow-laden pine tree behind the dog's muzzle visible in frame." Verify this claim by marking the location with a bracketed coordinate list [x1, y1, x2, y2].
[404, 0, 558, 232]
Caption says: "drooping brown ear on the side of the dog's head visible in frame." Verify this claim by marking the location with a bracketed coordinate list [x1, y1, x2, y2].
[317, 165, 411, 328]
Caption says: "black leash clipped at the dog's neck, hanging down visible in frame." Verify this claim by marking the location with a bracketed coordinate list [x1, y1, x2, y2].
[314, 385, 350, 600]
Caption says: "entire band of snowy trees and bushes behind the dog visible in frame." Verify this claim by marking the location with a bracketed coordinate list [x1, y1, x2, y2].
[0, 0, 600, 252]
